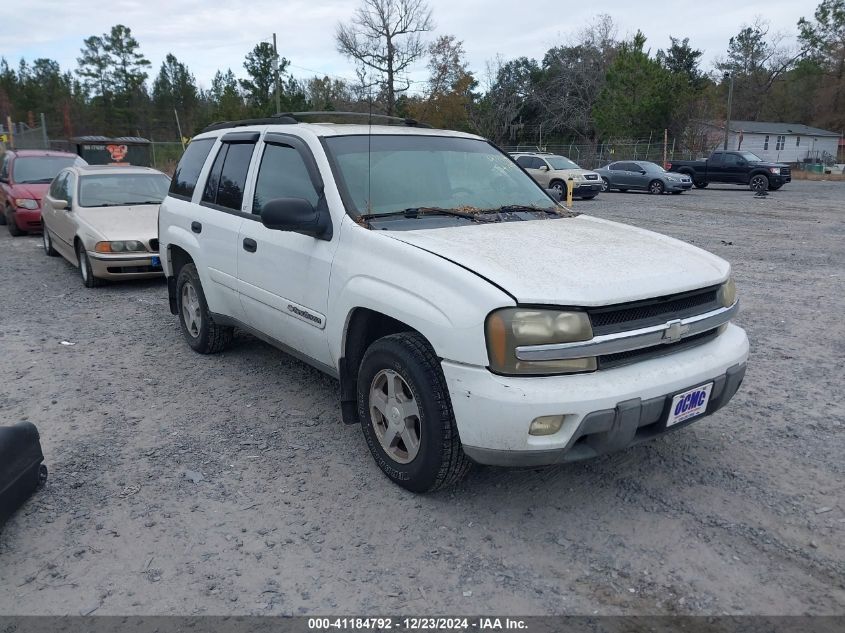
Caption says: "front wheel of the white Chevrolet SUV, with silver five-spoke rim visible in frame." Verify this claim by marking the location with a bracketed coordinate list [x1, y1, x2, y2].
[357, 332, 470, 492]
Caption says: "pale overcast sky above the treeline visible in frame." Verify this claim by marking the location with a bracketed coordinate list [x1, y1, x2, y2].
[0, 0, 818, 87]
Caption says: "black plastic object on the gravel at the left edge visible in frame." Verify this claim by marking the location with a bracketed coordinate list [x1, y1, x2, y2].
[0, 422, 47, 525]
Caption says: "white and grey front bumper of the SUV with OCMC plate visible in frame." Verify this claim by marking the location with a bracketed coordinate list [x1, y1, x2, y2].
[442, 325, 748, 466]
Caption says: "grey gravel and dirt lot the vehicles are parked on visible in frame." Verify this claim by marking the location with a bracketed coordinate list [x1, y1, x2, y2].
[0, 182, 845, 615]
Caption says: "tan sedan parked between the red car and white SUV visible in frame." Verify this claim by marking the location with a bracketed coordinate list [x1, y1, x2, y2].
[41, 165, 170, 288]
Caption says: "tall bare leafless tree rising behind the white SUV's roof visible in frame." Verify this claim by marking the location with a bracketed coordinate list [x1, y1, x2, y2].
[335, 0, 434, 115]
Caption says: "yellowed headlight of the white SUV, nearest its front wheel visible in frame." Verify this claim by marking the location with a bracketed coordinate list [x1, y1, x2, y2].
[485, 308, 596, 376]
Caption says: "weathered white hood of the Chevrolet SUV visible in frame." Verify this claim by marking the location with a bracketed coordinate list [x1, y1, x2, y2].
[382, 215, 730, 307]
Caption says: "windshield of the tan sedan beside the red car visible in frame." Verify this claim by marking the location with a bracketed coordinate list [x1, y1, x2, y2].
[79, 174, 170, 207]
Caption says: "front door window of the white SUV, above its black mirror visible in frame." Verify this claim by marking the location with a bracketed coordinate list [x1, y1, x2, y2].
[252, 144, 320, 215]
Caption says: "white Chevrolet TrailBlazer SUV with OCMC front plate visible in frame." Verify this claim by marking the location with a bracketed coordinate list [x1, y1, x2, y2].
[159, 115, 748, 491]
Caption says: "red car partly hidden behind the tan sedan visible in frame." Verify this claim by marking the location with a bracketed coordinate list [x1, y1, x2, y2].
[0, 149, 88, 236]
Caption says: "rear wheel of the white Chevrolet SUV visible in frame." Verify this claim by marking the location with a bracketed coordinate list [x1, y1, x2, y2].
[176, 264, 234, 354]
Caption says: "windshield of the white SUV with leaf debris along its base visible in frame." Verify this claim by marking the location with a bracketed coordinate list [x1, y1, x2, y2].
[325, 134, 555, 217]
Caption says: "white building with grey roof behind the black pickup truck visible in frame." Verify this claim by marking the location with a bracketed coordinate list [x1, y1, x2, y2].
[711, 121, 841, 164]
